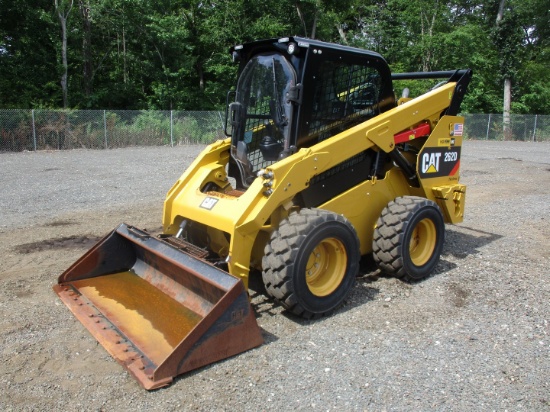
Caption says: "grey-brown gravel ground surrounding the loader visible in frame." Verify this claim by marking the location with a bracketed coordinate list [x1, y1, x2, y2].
[0, 141, 550, 411]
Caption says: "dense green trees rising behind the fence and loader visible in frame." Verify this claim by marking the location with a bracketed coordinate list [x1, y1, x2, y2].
[0, 0, 550, 114]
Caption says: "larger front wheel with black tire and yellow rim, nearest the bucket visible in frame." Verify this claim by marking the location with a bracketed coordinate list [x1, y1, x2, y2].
[262, 209, 361, 319]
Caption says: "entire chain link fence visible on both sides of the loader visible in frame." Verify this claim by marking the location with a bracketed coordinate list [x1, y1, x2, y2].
[0, 110, 550, 152]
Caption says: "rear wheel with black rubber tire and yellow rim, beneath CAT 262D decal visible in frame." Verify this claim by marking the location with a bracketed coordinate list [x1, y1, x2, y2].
[372, 196, 445, 281]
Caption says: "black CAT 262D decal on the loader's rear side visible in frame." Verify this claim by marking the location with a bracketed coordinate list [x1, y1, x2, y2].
[417, 146, 460, 179]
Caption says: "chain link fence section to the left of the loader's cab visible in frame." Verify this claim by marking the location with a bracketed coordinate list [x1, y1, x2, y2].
[0, 110, 224, 152]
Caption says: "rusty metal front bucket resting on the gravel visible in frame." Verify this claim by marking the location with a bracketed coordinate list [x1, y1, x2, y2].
[54, 224, 263, 389]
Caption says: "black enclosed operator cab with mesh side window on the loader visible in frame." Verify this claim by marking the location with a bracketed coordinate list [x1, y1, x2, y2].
[226, 37, 395, 188]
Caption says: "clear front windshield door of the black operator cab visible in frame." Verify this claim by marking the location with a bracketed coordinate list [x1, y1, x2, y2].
[231, 53, 296, 183]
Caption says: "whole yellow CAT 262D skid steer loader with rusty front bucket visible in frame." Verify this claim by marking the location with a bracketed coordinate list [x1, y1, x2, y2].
[54, 37, 472, 389]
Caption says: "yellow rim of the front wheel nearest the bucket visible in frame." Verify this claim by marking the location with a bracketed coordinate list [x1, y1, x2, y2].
[306, 238, 348, 296]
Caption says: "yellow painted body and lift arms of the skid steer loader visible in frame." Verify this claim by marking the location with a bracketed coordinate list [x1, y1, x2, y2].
[163, 83, 466, 285]
